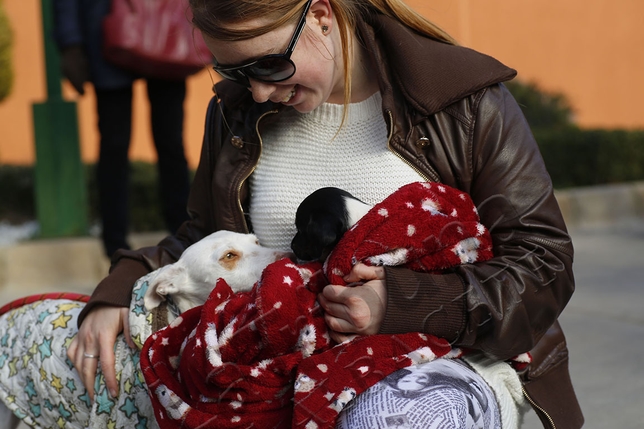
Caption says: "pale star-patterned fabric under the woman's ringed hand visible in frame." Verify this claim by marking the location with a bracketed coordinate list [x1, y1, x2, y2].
[0, 292, 157, 429]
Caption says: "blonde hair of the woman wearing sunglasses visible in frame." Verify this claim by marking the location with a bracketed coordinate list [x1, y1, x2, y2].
[190, 0, 456, 106]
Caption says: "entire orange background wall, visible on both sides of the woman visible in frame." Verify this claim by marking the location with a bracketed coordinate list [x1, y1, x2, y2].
[0, 0, 644, 167]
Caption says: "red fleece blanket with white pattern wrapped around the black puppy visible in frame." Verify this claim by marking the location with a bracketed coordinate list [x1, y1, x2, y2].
[141, 183, 500, 429]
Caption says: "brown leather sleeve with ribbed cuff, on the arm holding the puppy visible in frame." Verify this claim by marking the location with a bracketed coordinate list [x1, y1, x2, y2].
[381, 85, 574, 359]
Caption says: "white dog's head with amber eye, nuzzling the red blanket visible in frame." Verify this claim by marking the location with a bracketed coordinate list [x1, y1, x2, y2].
[144, 231, 291, 312]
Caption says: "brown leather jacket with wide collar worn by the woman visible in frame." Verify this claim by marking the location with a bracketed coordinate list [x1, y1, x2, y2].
[81, 10, 583, 429]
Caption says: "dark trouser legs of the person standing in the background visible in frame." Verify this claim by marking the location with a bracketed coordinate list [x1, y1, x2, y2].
[96, 79, 190, 257]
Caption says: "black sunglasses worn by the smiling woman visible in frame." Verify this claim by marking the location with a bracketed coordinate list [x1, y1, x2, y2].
[213, 0, 312, 87]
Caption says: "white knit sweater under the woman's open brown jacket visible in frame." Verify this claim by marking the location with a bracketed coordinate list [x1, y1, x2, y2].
[250, 93, 423, 249]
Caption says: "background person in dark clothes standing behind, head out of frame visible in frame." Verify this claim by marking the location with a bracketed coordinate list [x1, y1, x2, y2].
[54, 0, 190, 257]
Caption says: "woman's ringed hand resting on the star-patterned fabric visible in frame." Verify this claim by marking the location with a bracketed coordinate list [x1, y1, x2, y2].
[67, 306, 135, 400]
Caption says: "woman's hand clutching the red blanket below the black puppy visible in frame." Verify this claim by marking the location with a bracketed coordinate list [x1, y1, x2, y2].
[318, 264, 387, 343]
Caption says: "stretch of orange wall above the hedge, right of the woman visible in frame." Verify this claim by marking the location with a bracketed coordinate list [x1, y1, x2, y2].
[418, 0, 644, 129]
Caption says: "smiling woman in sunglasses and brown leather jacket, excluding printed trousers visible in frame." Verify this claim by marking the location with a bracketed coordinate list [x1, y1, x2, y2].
[68, 0, 583, 428]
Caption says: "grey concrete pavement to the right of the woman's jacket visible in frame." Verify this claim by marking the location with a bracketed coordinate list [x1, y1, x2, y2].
[523, 220, 644, 429]
